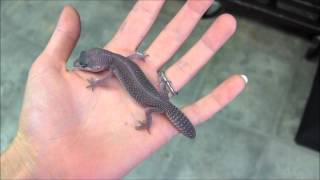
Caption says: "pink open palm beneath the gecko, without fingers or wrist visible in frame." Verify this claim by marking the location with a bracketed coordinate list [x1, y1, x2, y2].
[20, 51, 166, 177]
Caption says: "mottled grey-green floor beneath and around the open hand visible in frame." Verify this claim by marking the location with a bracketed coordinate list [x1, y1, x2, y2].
[1, 0, 319, 179]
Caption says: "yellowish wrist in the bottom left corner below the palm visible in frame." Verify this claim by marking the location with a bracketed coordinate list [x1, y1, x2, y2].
[1, 131, 35, 179]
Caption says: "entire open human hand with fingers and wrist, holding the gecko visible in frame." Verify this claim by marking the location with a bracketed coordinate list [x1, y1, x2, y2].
[1, 0, 245, 179]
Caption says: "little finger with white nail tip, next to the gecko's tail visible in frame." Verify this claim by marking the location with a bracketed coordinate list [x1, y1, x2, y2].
[183, 75, 248, 124]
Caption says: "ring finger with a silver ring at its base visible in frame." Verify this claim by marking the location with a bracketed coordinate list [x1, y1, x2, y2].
[166, 14, 236, 90]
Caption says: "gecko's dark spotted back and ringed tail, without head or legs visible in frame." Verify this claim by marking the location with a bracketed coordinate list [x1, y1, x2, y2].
[111, 55, 196, 138]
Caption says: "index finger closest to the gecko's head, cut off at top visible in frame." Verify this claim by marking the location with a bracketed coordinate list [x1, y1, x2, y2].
[105, 0, 165, 52]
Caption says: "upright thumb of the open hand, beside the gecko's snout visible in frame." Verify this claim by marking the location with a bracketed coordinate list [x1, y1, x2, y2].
[41, 6, 80, 67]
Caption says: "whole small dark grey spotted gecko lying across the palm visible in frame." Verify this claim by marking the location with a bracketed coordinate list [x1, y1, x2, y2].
[73, 48, 196, 138]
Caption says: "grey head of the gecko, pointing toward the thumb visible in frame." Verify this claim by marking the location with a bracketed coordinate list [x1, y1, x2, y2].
[73, 48, 110, 72]
